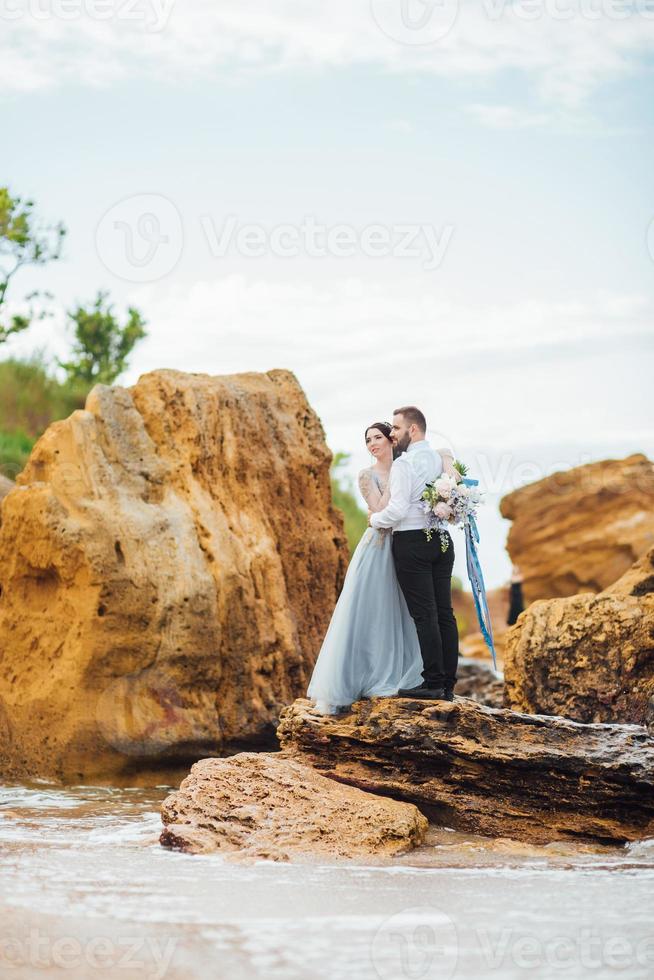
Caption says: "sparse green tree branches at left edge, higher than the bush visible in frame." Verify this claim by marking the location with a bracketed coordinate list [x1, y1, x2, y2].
[0, 187, 66, 344]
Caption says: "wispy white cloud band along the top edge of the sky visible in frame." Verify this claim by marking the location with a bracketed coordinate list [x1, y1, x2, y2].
[0, 0, 654, 106]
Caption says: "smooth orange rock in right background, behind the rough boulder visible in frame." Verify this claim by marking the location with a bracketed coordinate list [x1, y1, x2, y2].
[500, 454, 654, 603]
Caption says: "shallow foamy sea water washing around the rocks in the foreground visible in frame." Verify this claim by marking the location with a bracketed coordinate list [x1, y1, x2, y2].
[0, 780, 654, 980]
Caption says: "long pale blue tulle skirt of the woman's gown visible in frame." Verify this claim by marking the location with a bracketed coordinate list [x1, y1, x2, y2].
[307, 527, 423, 714]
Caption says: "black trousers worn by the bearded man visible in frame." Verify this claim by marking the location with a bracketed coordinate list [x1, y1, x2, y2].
[393, 531, 459, 687]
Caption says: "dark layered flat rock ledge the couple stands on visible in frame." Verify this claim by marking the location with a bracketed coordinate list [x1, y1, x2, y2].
[278, 698, 654, 843]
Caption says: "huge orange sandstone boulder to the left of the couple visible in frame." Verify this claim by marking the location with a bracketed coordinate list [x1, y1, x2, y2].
[0, 371, 347, 779]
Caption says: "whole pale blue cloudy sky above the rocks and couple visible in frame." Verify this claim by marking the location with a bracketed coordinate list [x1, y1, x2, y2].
[0, 0, 654, 587]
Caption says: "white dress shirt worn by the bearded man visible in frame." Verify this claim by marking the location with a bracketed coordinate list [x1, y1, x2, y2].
[370, 439, 443, 531]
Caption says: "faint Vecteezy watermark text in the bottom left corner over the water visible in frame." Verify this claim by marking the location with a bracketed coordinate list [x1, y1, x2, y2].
[0, 928, 177, 980]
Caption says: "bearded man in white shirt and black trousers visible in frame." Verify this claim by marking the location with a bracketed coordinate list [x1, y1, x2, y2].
[368, 405, 459, 701]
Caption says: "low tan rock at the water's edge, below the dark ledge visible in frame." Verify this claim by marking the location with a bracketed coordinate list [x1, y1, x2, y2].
[161, 752, 427, 861]
